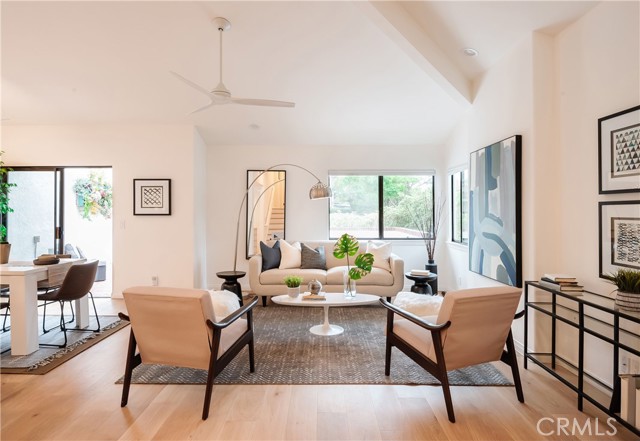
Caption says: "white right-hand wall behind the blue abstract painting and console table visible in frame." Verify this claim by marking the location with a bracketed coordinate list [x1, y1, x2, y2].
[445, 2, 640, 382]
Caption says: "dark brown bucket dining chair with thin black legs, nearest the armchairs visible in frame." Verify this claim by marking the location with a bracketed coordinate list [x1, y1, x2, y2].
[38, 260, 100, 348]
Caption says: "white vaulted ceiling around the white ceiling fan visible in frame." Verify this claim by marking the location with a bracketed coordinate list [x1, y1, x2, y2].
[0, 1, 595, 145]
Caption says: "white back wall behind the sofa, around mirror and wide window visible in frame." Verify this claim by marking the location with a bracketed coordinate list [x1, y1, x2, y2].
[207, 146, 448, 289]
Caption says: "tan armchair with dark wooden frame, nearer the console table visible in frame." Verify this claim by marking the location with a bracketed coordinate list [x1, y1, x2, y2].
[380, 287, 524, 423]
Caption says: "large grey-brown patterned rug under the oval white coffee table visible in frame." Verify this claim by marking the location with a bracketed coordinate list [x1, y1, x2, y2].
[117, 305, 513, 386]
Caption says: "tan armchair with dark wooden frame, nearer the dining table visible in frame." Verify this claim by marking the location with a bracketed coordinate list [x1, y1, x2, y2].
[119, 286, 258, 420]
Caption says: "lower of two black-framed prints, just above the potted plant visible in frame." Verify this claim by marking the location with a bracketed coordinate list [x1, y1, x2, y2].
[598, 201, 640, 277]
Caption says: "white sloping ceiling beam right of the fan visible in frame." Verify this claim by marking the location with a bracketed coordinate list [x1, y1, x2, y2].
[354, 0, 473, 106]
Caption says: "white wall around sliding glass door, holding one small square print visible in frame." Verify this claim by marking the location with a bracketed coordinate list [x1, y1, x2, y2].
[2, 125, 205, 295]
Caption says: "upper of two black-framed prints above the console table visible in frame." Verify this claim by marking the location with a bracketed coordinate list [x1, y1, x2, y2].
[598, 106, 640, 194]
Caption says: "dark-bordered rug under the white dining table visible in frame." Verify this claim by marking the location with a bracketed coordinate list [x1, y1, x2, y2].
[0, 316, 129, 375]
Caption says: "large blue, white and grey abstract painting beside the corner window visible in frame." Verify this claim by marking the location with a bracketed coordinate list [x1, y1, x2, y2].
[469, 135, 522, 287]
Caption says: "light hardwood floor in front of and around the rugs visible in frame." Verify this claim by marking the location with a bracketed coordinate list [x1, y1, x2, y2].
[0, 299, 637, 441]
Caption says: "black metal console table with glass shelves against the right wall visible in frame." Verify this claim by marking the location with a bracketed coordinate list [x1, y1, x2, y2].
[524, 281, 640, 435]
